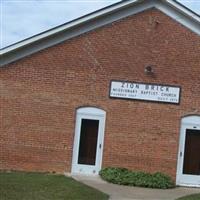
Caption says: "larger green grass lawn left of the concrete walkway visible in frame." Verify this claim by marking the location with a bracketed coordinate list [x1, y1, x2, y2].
[0, 171, 108, 200]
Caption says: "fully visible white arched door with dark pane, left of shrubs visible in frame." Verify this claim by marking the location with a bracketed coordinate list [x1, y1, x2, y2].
[72, 107, 106, 175]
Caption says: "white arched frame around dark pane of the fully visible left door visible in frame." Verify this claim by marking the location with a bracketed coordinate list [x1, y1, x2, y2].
[71, 107, 106, 175]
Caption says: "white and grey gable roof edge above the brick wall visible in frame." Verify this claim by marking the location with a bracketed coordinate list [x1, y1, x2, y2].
[0, 0, 200, 67]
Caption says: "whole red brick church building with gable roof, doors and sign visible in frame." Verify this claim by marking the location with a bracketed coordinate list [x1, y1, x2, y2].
[0, 0, 200, 186]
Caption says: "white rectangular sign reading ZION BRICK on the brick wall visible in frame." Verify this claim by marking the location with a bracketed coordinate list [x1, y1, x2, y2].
[110, 81, 181, 104]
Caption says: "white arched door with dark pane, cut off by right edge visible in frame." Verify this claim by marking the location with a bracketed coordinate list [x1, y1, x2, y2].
[176, 116, 200, 187]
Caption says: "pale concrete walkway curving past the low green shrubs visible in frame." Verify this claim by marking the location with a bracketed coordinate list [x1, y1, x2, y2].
[73, 175, 200, 200]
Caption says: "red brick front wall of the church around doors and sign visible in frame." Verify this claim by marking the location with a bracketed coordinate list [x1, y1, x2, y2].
[0, 10, 200, 177]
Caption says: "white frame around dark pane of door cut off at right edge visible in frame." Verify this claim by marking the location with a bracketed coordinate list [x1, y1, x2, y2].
[176, 115, 200, 187]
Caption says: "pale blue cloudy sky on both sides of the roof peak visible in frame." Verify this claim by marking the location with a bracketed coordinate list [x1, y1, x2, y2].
[0, 0, 200, 48]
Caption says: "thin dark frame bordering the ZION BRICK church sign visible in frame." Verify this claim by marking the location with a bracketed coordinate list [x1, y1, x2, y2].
[109, 79, 182, 105]
